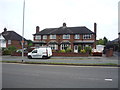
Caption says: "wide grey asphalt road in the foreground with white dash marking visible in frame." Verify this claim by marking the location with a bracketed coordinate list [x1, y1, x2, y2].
[2, 63, 118, 88]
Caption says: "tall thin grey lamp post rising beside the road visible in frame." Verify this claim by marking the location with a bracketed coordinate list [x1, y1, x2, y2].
[22, 0, 25, 62]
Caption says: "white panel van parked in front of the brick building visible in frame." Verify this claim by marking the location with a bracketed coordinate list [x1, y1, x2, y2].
[28, 47, 52, 59]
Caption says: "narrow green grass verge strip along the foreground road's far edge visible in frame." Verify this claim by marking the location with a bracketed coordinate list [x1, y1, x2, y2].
[1, 61, 120, 67]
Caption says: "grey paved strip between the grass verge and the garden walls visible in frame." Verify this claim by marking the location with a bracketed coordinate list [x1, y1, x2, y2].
[1, 54, 119, 64]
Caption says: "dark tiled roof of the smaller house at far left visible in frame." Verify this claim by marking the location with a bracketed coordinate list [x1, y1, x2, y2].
[2, 31, 26, 41]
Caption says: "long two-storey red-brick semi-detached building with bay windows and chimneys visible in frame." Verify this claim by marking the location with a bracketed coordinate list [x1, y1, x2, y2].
[33, 23, 97, 53]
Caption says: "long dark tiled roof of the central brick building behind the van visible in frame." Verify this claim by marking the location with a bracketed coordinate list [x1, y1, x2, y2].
[34, 26, 94, 35]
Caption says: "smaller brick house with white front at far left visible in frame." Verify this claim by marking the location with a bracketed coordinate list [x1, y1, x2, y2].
[0, 28, 27, 49]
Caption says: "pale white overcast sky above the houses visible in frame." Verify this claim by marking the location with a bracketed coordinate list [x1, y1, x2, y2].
[0, 0, 119, 40]
